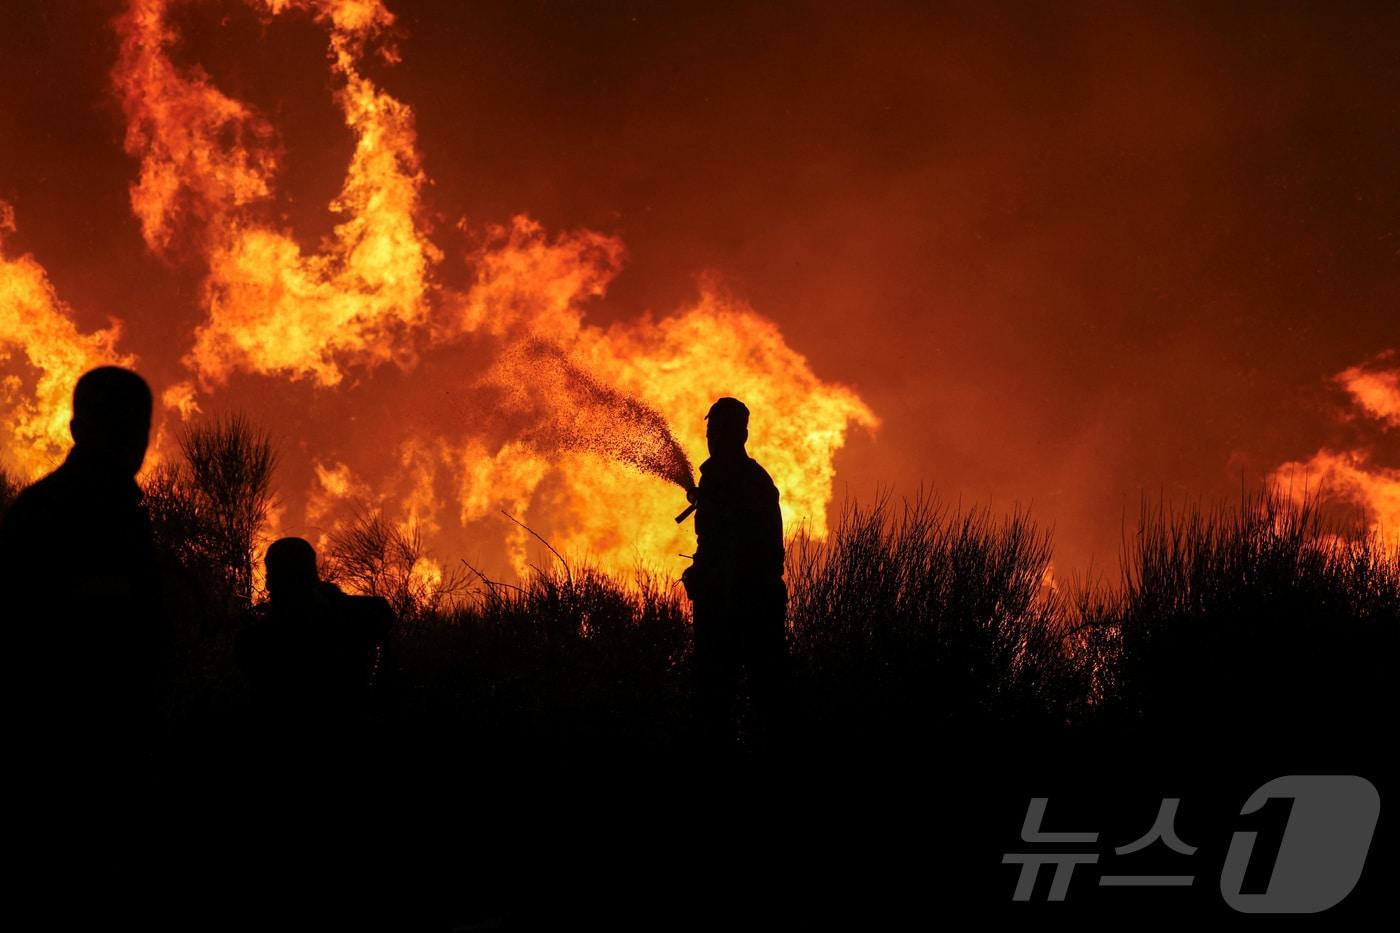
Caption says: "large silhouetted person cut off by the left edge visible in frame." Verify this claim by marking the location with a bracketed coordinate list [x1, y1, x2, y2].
[0, 366, 164, 754]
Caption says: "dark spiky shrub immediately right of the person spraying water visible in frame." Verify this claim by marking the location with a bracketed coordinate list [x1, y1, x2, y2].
[787, 487, 1088, 734]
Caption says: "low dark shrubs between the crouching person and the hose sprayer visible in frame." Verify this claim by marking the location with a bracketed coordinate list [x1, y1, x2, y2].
[398, 562, 690, 754]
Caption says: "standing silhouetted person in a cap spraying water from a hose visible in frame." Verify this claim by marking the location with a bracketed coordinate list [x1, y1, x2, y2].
[682, 398, 787, 747]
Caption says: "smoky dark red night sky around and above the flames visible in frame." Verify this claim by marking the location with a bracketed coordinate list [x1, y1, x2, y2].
[0, 0, 1400, 567]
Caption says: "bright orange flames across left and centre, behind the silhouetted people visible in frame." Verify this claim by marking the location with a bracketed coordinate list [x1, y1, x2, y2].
[0, 0, 878, 580]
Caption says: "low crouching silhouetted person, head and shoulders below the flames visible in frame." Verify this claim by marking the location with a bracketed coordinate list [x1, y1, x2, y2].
[238, 538, 393, 731]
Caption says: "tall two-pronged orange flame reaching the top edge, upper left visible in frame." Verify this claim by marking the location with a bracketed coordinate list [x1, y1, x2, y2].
[113, 0, 440, 388]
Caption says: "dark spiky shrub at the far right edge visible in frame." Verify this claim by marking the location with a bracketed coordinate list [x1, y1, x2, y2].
[1075, 489, 1400, 741]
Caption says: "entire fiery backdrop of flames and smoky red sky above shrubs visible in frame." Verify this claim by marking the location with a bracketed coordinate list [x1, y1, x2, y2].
[0, 0, 1400, 580]
